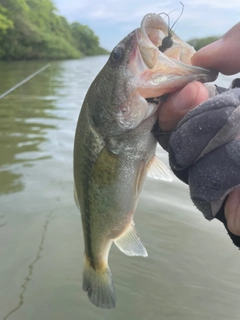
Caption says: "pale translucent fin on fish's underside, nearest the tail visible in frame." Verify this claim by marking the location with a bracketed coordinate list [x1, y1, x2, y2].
[114, 222, 148, 257]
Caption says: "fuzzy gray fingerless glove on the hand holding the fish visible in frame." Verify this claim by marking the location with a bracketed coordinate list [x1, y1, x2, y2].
[153, 79, 240, 247]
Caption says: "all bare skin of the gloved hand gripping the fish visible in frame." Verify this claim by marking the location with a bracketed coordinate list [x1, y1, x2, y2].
[159, 23, 240, 236]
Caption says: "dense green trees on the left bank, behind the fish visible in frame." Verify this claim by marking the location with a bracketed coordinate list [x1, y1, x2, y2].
[0, 0, 107, 59]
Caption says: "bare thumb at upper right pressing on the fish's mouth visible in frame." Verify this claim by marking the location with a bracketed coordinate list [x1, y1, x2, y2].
[191, 22, 240, 75]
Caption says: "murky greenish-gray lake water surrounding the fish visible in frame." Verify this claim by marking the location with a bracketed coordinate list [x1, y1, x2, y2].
[0, 56, 240, 320]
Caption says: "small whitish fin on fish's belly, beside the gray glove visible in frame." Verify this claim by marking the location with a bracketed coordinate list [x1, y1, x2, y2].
[147, 156, 173, 181]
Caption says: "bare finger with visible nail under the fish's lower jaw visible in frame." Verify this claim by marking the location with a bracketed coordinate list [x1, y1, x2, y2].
[159, 81, 209, 131]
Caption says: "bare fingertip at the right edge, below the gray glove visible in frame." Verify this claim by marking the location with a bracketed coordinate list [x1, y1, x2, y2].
[224, 188, 240, 236]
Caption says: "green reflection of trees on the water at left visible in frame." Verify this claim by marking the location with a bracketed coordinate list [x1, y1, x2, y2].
[0, 62, 61, 194]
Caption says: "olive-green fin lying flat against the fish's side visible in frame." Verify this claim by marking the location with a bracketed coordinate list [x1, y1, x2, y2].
[93, 146, 119, 185]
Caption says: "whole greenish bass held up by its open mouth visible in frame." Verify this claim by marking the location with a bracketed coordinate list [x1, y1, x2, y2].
[74, 13, 216, 309]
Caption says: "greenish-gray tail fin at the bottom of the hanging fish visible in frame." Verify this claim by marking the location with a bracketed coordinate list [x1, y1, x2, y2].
[83, 260, 116, 309]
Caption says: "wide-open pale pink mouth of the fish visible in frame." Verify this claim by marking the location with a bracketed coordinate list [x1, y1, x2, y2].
[132, 13, 218, 99]
